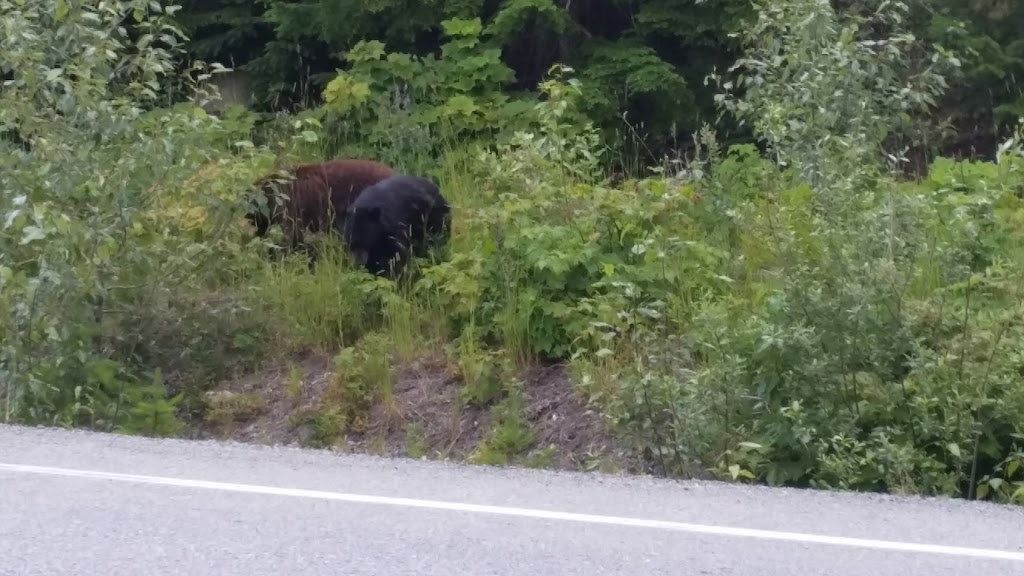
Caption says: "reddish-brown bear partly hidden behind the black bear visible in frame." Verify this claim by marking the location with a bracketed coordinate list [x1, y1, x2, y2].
[246, 159, 395, 249]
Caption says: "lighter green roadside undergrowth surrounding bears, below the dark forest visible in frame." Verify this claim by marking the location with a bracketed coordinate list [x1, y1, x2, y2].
[0, 0, 1024, 502]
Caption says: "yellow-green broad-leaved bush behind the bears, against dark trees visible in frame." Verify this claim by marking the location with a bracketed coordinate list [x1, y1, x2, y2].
[318, 18, 529, 165]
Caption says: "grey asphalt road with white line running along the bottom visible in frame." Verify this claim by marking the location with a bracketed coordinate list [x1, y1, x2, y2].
[0, 425, 1024, 576]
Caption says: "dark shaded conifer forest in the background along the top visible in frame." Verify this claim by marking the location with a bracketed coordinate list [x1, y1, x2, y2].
[172, 0, 1024, 172]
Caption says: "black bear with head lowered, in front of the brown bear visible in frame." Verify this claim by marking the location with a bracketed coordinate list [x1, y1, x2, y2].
[338, 174, 452, 279]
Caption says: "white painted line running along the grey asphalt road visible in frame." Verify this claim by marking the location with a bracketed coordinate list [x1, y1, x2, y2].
[0, 462, 1024, 562]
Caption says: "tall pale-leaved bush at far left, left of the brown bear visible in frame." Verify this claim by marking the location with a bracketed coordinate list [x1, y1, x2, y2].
[0, 1, 268, 434]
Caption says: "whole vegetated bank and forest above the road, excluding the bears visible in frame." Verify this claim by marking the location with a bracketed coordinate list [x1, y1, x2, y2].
[0, 0, 1024, 503]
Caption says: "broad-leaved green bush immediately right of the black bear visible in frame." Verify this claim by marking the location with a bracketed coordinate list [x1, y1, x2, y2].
[423, 69, 733, 359]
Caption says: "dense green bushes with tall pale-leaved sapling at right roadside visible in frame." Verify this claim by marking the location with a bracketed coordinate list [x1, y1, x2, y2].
[584, 2, 1024, 498]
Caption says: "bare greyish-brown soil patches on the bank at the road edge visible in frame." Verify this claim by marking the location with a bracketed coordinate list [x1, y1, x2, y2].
[193, 348, 639, 471]
